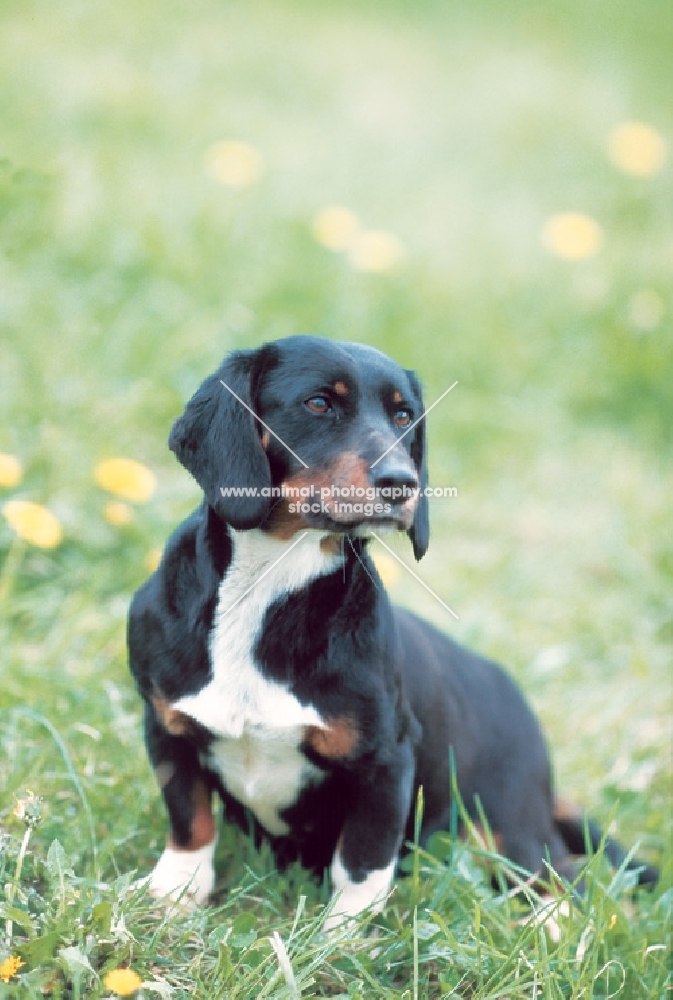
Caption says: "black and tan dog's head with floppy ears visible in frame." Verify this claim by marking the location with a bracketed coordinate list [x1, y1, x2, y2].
[169, 336, 429, 559]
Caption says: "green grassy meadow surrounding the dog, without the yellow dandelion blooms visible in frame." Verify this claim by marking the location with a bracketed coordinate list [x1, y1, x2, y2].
[0, 0, 673, 1000]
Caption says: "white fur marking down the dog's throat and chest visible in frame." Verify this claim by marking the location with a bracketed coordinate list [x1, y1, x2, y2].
[173, 530, 342, 834]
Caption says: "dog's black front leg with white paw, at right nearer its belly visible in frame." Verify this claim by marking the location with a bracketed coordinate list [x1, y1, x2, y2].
[324, 742, 414, 931]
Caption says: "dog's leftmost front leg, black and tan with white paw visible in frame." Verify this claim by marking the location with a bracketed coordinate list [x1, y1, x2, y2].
[145, 704, 217, 903]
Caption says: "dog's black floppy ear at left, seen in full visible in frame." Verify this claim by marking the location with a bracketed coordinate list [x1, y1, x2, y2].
[168, 348, 271, 528]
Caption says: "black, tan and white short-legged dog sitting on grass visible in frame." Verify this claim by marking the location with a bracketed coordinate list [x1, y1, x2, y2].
[128, 336, 656, 930]
